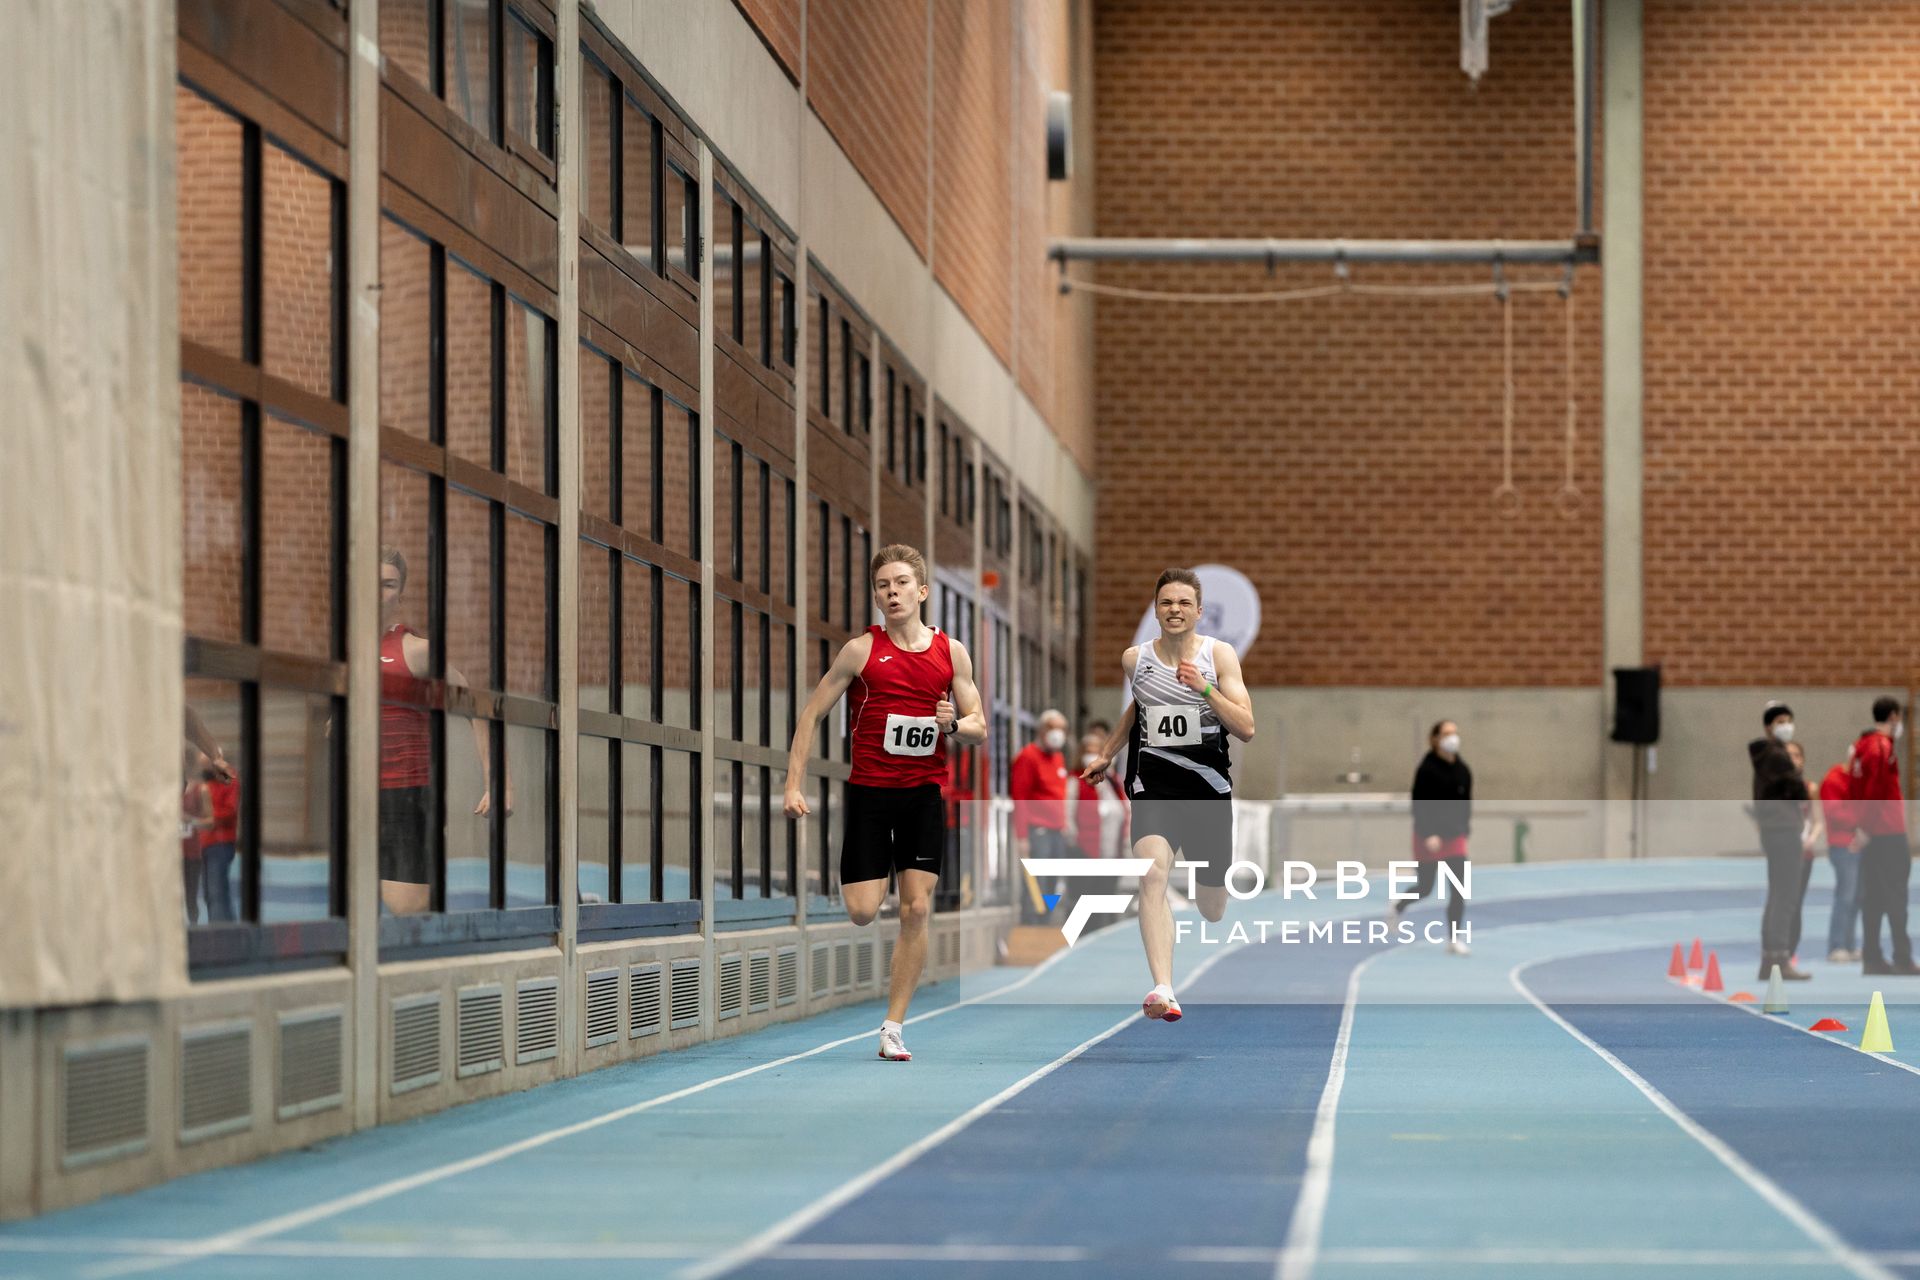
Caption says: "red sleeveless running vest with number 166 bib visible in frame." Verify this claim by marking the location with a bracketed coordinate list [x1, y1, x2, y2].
[847, 624, 958, 787]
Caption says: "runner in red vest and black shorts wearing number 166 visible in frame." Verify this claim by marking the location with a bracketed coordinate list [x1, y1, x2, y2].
[787, 545, 987, 1063]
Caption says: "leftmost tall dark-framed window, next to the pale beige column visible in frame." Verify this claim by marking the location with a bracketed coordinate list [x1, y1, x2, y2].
[175, 83, 348, 969]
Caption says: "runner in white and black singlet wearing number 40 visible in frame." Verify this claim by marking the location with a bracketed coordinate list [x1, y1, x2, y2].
[1081, 568, 1254, 1023]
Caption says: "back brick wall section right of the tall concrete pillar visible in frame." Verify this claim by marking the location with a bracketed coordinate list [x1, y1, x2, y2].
[1635, 0, 1920, 685]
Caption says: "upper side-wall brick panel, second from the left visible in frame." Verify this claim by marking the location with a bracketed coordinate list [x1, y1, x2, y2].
[806, 0, 929, 257]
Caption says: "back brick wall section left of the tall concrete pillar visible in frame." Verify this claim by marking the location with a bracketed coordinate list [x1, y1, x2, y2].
[1077, 0, 1605, 685]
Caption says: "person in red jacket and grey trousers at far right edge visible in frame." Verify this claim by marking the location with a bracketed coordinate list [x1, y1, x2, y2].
[1847, 697, 1920, 977]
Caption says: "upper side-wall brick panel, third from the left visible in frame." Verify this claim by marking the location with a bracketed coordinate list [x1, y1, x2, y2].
[933, 0, 1014, 363]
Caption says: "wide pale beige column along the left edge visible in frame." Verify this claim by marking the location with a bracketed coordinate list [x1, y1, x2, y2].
[0, 0, 186, 1007]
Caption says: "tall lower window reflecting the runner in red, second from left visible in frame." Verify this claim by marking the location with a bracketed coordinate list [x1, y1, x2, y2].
[380, 217, 559, 924]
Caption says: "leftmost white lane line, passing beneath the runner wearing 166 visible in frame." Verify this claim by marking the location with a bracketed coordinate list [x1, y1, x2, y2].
[86, 931, 1108, 1280]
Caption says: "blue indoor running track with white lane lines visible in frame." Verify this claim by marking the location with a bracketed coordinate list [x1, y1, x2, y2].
[0, 860, 1920, 1280]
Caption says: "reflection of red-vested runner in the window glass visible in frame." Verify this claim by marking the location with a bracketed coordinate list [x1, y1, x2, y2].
[380, 549, 513, 915]
